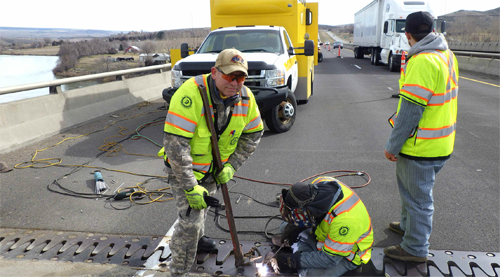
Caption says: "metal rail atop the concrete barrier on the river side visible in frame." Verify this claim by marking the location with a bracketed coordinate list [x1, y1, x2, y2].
[0, 64, 171, 95]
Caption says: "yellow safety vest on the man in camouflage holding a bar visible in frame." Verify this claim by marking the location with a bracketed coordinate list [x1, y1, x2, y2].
[158, 74, 264, 180]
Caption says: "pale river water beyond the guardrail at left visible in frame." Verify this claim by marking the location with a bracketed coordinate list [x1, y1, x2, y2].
[0, 55, 99, 103]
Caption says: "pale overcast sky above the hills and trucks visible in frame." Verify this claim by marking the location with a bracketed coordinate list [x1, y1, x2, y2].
[0, 0, 500, 32]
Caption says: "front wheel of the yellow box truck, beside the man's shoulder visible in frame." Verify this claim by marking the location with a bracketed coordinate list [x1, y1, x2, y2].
[265, 90, 297, 133]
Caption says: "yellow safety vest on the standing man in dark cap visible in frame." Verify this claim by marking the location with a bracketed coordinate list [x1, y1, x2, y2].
[389, 50, 458, 158]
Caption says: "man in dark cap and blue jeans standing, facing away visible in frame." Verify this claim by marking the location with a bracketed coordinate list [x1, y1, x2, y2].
[384, 12, 458, 262]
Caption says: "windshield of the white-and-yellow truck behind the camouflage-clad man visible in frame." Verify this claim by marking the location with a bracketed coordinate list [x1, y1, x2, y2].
[197, 30, 283, 54]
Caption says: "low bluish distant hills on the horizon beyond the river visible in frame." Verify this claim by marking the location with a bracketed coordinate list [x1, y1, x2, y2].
[0, 27, 120, 40]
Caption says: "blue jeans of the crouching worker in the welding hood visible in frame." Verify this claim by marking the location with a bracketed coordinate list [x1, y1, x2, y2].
[292, 229, 358, 277]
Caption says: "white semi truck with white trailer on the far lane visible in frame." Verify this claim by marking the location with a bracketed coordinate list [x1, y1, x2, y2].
[352, 0, 444, 71]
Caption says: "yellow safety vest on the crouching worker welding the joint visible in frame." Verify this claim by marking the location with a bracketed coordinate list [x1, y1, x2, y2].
[315, 180, 373, 265]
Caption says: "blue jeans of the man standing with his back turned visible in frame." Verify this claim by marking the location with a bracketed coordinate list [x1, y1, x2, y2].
[396, 156, 446, 257]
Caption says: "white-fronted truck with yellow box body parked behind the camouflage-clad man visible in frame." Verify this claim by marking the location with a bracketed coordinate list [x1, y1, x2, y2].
[163, 0, 318, 133]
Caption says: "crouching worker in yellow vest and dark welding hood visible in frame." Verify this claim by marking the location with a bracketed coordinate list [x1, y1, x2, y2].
[274, 177, 373, 277]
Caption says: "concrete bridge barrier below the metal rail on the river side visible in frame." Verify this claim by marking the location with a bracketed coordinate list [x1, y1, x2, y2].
[0, 71, 171, 153]
